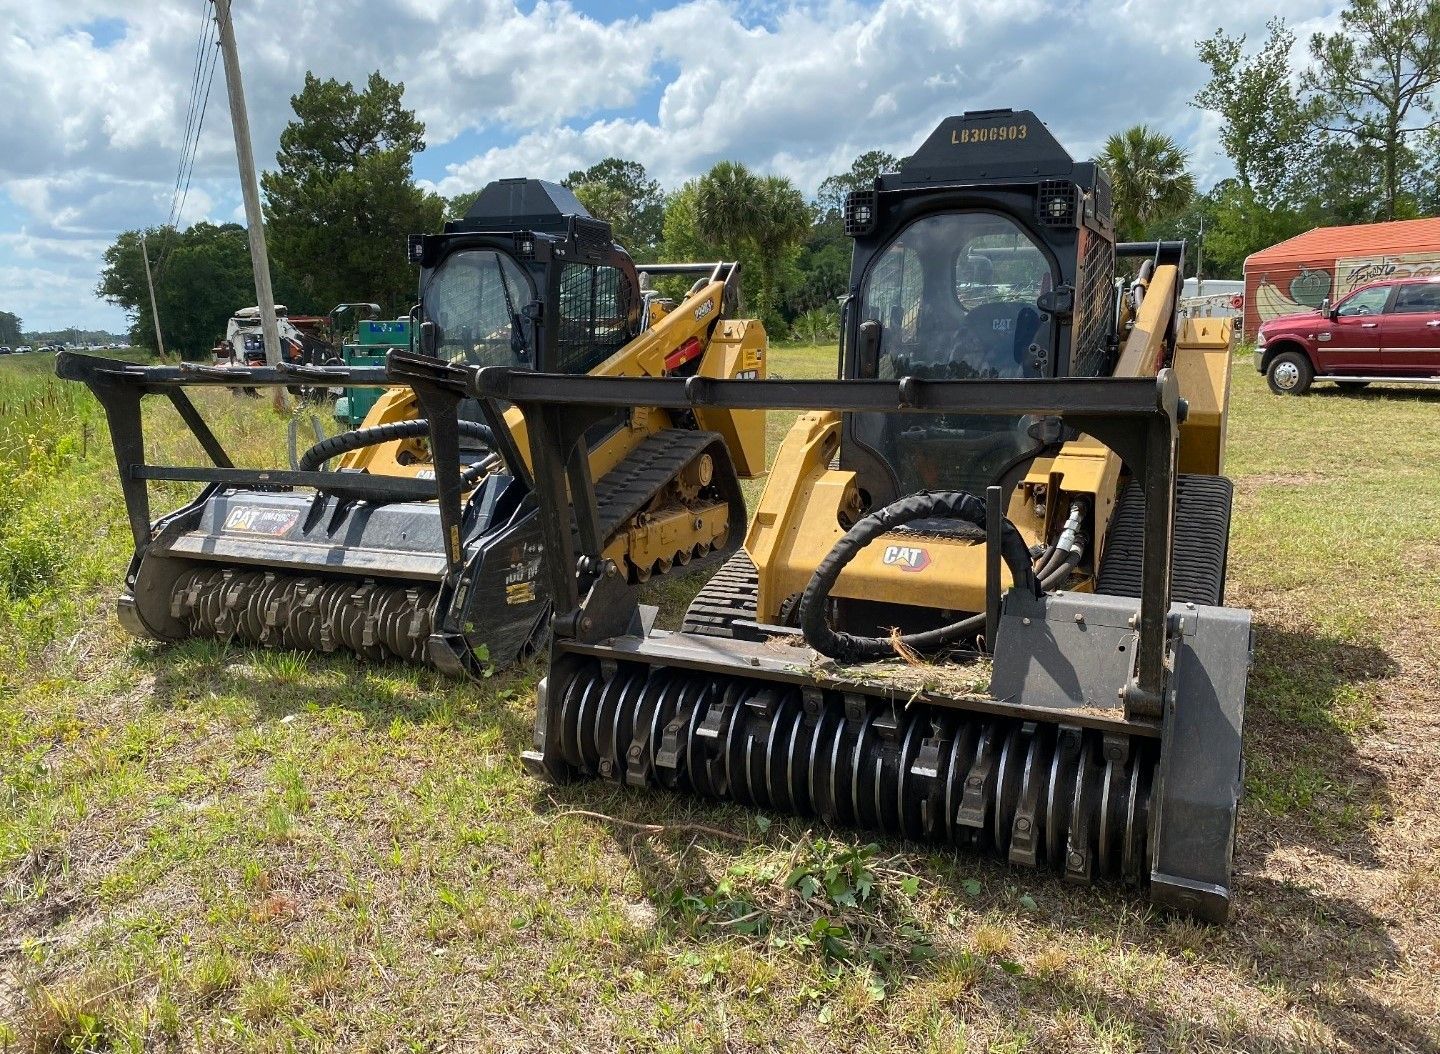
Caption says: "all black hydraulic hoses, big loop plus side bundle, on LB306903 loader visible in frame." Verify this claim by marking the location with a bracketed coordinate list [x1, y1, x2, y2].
[799, 491, 1086, 662]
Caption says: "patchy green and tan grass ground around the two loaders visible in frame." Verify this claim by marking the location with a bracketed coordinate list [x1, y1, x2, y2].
[0, 348, 1440, 1051]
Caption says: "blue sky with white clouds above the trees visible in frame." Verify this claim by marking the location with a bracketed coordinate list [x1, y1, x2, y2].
[0, 0, 1335, 330]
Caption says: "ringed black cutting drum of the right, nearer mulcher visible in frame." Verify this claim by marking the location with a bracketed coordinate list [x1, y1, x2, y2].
[552, 661, 1159, 884]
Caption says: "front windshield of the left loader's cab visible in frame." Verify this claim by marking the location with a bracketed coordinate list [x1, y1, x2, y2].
[420, 249, 534, 366]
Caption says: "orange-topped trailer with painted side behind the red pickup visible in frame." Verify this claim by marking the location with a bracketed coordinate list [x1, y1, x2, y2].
[1244, 219, 1440, 340]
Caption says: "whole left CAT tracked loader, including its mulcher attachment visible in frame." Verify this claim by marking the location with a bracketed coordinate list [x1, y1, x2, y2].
[56, 180, 766, 674]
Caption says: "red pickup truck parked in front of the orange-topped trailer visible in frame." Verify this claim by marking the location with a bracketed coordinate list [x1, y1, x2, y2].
[1256, 276, 1440, 395]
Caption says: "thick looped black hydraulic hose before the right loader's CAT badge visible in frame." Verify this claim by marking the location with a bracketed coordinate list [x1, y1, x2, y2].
[801, 491, 1038, 662]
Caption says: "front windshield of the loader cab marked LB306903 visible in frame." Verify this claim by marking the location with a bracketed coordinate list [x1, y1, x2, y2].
[852, 212, 1056, 494]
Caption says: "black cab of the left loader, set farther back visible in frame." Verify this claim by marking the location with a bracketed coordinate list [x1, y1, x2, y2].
[409, 179, 641, 374]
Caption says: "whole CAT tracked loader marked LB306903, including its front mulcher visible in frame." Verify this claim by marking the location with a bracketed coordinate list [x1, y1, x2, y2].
[443, 111, 1250, 920]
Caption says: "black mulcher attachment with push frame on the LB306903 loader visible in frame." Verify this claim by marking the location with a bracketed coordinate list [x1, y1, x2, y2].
[477, 369, 1250, 920]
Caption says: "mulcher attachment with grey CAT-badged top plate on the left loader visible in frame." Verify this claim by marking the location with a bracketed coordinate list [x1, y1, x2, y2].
[56, 353, 549, 674]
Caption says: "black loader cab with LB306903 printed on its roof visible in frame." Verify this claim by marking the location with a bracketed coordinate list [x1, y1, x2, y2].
[841, 109, 1116, 508]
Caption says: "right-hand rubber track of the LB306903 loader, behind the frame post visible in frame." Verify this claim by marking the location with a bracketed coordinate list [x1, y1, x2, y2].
[1096, 475, 1234, 605]
